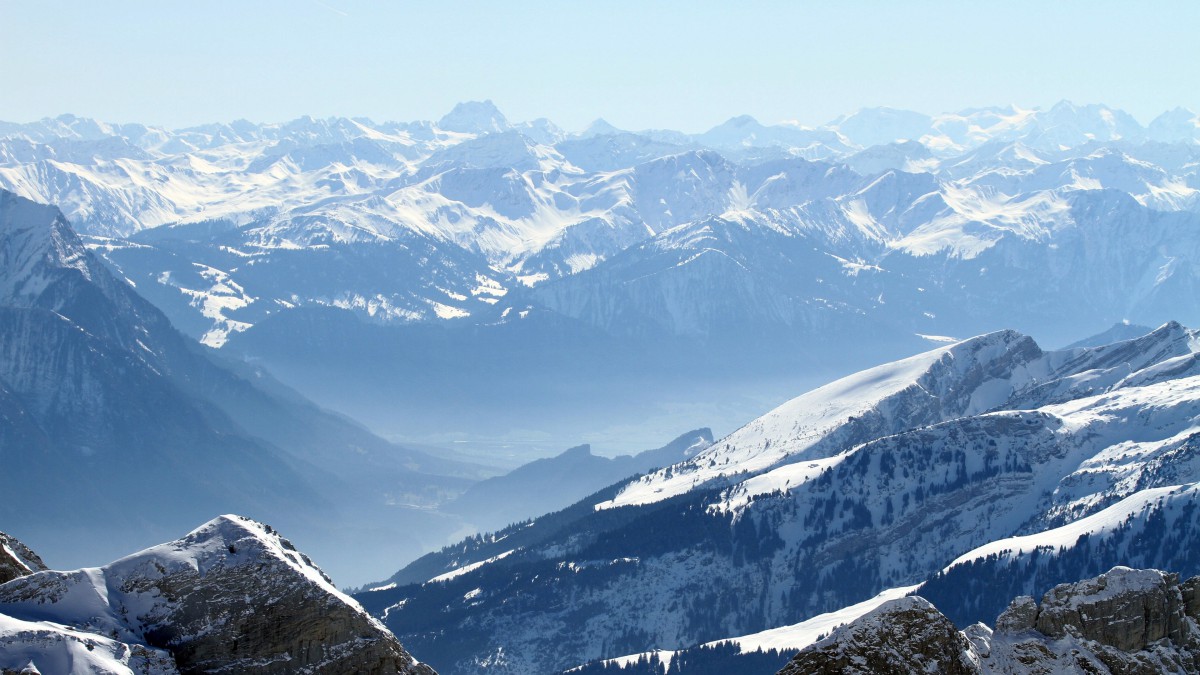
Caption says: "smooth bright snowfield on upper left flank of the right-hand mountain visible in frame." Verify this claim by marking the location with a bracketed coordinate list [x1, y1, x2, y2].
[596, 331, 1050, 508]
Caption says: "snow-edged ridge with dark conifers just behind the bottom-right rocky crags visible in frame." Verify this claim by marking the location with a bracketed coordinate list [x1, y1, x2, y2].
[580, 485, 1200, 675]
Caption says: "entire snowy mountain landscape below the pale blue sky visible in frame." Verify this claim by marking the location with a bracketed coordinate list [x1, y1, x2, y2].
[0, 97, 1200, 675]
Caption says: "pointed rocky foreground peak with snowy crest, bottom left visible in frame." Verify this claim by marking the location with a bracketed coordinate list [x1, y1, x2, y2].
[0, 515, 433, 675]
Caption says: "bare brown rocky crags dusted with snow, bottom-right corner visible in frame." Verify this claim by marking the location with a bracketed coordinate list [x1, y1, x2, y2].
[780, 567, 1200, 675]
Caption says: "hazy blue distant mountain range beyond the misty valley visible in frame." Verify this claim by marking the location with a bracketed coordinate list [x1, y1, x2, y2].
[0, 101, 1200, 456]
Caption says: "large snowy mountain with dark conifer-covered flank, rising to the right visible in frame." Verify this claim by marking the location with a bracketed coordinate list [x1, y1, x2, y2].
[358, 323, 1200, 673]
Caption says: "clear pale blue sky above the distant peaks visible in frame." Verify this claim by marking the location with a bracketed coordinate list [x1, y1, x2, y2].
[0, 0, 1200, 132]
